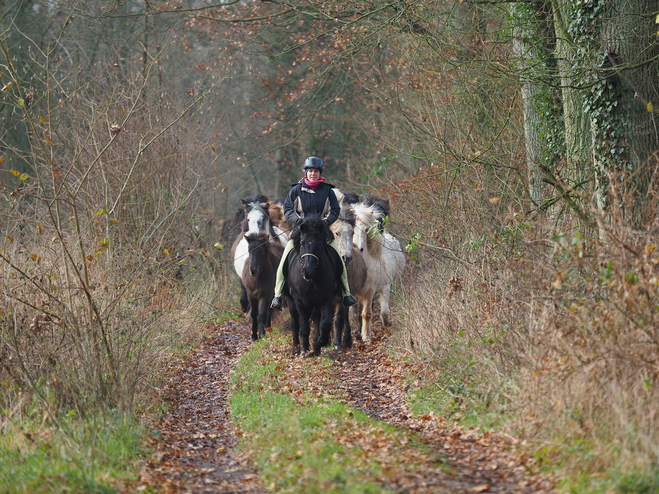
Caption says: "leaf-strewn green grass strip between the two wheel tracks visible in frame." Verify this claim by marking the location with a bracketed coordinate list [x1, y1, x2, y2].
[231, 332, 478, 493]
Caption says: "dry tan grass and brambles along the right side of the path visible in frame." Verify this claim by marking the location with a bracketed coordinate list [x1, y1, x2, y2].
[386, 161, 659, 474]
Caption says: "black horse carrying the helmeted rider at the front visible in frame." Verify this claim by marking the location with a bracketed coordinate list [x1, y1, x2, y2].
[284, 216, 343, 355]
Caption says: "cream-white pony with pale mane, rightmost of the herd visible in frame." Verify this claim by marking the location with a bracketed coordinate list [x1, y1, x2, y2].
[353, 203, 405, 332]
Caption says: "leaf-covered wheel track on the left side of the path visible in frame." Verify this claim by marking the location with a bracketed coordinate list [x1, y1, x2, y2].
[136, 322, 267, 493]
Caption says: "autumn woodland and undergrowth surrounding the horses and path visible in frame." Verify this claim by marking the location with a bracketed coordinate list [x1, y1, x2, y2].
[0, 0, 659, 492]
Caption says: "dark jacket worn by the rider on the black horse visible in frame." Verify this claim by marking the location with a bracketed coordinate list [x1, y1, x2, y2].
[283, 180, 341, 229]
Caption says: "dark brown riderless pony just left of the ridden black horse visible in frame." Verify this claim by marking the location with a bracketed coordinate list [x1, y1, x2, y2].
[241, 232, 284, 341]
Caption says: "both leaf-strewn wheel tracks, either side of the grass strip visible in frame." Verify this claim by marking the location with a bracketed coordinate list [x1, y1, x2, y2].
[136, 321, 554, 493]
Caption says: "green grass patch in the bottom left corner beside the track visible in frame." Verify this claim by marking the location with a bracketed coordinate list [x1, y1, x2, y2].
[0, 405, 145, 494]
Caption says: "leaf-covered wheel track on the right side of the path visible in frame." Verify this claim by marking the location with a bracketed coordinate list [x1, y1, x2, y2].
[322, 325, 552, 493]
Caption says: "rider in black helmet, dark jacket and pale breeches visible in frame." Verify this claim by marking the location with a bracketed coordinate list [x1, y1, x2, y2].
[270, 156, 357, 310]
